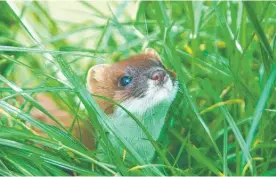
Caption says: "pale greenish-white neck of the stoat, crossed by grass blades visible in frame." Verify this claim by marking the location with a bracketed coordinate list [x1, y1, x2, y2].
[107, 103, 170, 161]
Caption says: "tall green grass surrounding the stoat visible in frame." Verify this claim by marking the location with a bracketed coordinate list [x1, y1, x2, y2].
[0, 1, 276, 176]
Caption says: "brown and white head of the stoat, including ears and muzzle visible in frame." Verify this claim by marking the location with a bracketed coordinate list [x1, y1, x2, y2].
[87, 49, 177, 114]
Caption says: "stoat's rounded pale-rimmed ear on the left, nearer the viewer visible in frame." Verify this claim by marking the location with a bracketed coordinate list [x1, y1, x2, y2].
[86, 64, 110, 93]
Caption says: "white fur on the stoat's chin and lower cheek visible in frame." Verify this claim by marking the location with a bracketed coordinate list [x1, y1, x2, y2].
[113, 79, 178, 117]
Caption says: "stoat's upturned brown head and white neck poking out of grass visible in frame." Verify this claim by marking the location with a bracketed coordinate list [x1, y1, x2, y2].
[87, 48, 178, 161]
